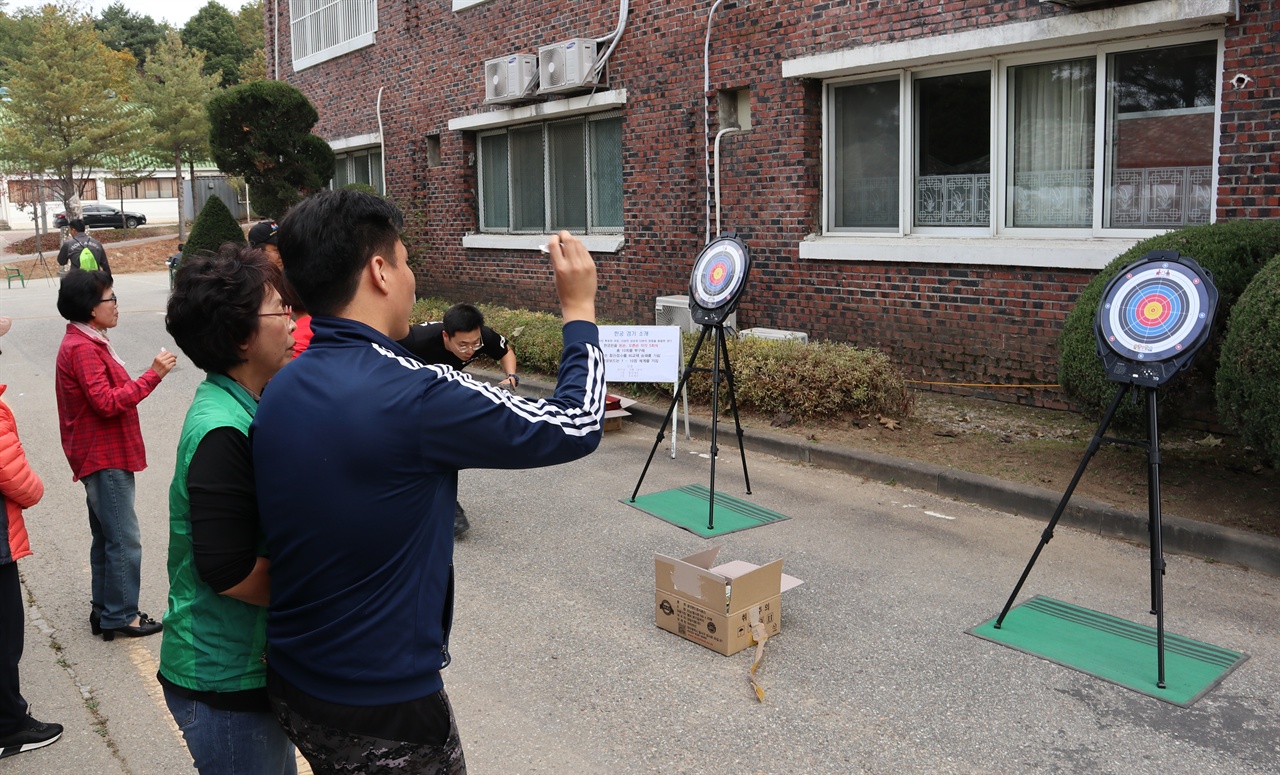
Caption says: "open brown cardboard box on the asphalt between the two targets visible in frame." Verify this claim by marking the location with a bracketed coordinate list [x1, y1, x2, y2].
[654, 547, 804, 656]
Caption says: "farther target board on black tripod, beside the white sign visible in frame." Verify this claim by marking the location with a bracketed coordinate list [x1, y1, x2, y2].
[631, 236, 751, 530]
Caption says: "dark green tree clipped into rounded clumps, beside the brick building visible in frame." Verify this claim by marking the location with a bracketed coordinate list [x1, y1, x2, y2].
[209, 81, 334, 218]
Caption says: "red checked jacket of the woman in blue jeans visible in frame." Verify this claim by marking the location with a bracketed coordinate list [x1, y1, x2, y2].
[55, 323, 160, 482]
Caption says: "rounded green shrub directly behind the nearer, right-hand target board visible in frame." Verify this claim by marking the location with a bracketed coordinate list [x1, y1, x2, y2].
[1057, 220, 1280, 428]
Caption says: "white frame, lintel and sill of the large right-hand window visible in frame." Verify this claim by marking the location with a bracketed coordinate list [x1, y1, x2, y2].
[782, 0, 1234, 269]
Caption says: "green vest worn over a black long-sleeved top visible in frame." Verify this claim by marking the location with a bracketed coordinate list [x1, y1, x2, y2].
[160, 374, 266, 692]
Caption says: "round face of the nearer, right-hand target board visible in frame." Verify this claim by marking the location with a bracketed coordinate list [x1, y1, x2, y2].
[1098, 254, 1217, 363]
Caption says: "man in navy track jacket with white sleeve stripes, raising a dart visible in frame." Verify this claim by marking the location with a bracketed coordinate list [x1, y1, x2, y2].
[252, 191, 604, 772]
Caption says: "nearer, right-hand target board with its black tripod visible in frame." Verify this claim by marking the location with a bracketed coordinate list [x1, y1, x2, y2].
[995, 251, 1217, 689]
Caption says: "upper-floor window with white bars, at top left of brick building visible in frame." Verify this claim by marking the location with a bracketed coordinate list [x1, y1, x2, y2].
[289, 0, 378, 70]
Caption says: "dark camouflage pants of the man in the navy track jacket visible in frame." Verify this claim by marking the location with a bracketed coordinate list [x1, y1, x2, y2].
[271, 689, 467, 775]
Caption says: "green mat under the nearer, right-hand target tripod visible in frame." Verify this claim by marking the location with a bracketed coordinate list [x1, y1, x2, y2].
[968, 596, 1249, 707]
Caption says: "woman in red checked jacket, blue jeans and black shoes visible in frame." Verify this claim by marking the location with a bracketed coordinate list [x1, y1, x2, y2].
[55, 272, 178, 640]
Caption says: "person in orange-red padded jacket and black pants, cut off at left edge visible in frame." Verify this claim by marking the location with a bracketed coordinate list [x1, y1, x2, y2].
[0, 318, 63, 758]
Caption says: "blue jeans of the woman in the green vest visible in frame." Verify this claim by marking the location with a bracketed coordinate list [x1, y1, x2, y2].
[164, 687, 298, 775]
